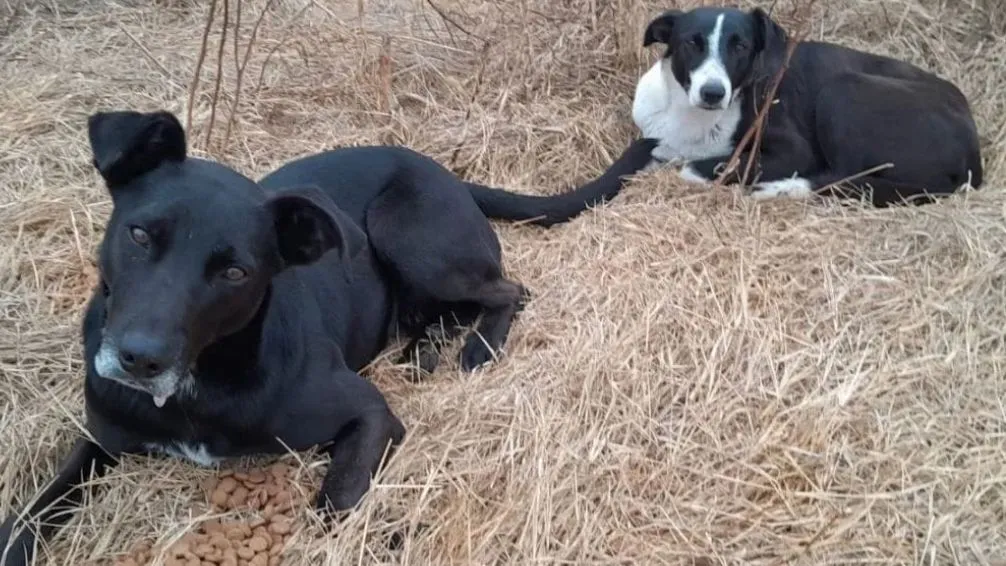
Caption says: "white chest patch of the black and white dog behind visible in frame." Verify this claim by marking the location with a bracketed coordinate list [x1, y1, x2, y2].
[632, 61, 741, 165]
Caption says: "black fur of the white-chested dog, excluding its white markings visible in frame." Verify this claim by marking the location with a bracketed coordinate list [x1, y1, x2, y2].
[644, 8, 983, 206]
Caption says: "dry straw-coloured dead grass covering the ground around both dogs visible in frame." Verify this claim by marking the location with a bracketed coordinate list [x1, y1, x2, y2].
[0, 0, 1006, 564]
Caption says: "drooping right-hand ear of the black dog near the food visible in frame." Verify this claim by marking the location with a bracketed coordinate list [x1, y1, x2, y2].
[268, 187, 367, 266]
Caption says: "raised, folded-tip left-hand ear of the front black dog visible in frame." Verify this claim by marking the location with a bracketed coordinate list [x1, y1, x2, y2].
[88, 111, 186, 188]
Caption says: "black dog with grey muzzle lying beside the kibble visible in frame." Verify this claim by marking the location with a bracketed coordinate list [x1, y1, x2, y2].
[0, 112, 656, 566]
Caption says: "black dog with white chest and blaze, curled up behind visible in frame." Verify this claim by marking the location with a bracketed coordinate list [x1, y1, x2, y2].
[633, 8, 982, 206]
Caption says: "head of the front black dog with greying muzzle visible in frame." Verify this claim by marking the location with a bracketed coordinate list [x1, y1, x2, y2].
[88, 112, 365, 406]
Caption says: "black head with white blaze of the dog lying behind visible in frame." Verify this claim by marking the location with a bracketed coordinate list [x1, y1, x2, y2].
[643, 8, 787, 111]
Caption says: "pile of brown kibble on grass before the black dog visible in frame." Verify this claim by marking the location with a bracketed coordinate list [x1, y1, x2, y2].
[114, 462, 305, 566]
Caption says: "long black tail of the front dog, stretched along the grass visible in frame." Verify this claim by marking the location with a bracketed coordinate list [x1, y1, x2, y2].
[465, 138, 658, 226]
